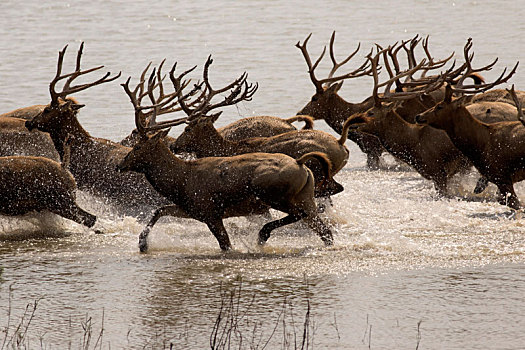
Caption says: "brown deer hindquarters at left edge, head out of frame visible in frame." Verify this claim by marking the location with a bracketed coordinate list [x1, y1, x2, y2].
[0, 156, 97, 227]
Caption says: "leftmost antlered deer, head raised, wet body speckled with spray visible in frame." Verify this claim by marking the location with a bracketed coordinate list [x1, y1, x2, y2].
[25, 43, 186, 217]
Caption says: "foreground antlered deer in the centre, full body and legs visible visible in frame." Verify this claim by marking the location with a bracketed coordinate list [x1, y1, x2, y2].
[117, 63, 333, 252]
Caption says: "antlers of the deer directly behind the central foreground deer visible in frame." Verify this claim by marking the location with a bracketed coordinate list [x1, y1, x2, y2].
[170, 55, 259, 121]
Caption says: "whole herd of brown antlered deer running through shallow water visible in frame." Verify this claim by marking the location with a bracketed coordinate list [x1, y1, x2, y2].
[0, 32, 525, 252]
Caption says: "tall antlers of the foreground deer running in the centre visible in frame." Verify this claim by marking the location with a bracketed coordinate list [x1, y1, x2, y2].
[121, 60, 194, 136]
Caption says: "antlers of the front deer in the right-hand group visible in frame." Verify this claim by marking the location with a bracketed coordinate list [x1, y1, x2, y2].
[295, 31, 371, 92]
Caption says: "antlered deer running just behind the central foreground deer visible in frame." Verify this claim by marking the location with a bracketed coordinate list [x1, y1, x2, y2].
[170, 56, 349, 197]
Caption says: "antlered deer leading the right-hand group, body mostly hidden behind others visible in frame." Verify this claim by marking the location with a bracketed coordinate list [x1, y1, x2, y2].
[295, 31, 384, 169]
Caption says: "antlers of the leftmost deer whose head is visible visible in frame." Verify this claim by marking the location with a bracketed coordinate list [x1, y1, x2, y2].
[49, 42, 121, 105]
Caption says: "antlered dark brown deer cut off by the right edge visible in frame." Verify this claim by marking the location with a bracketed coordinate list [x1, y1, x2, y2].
[416, 54, 525, 210]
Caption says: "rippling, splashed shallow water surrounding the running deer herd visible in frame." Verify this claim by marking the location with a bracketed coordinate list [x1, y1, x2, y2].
[0, 0, 525, 349]
